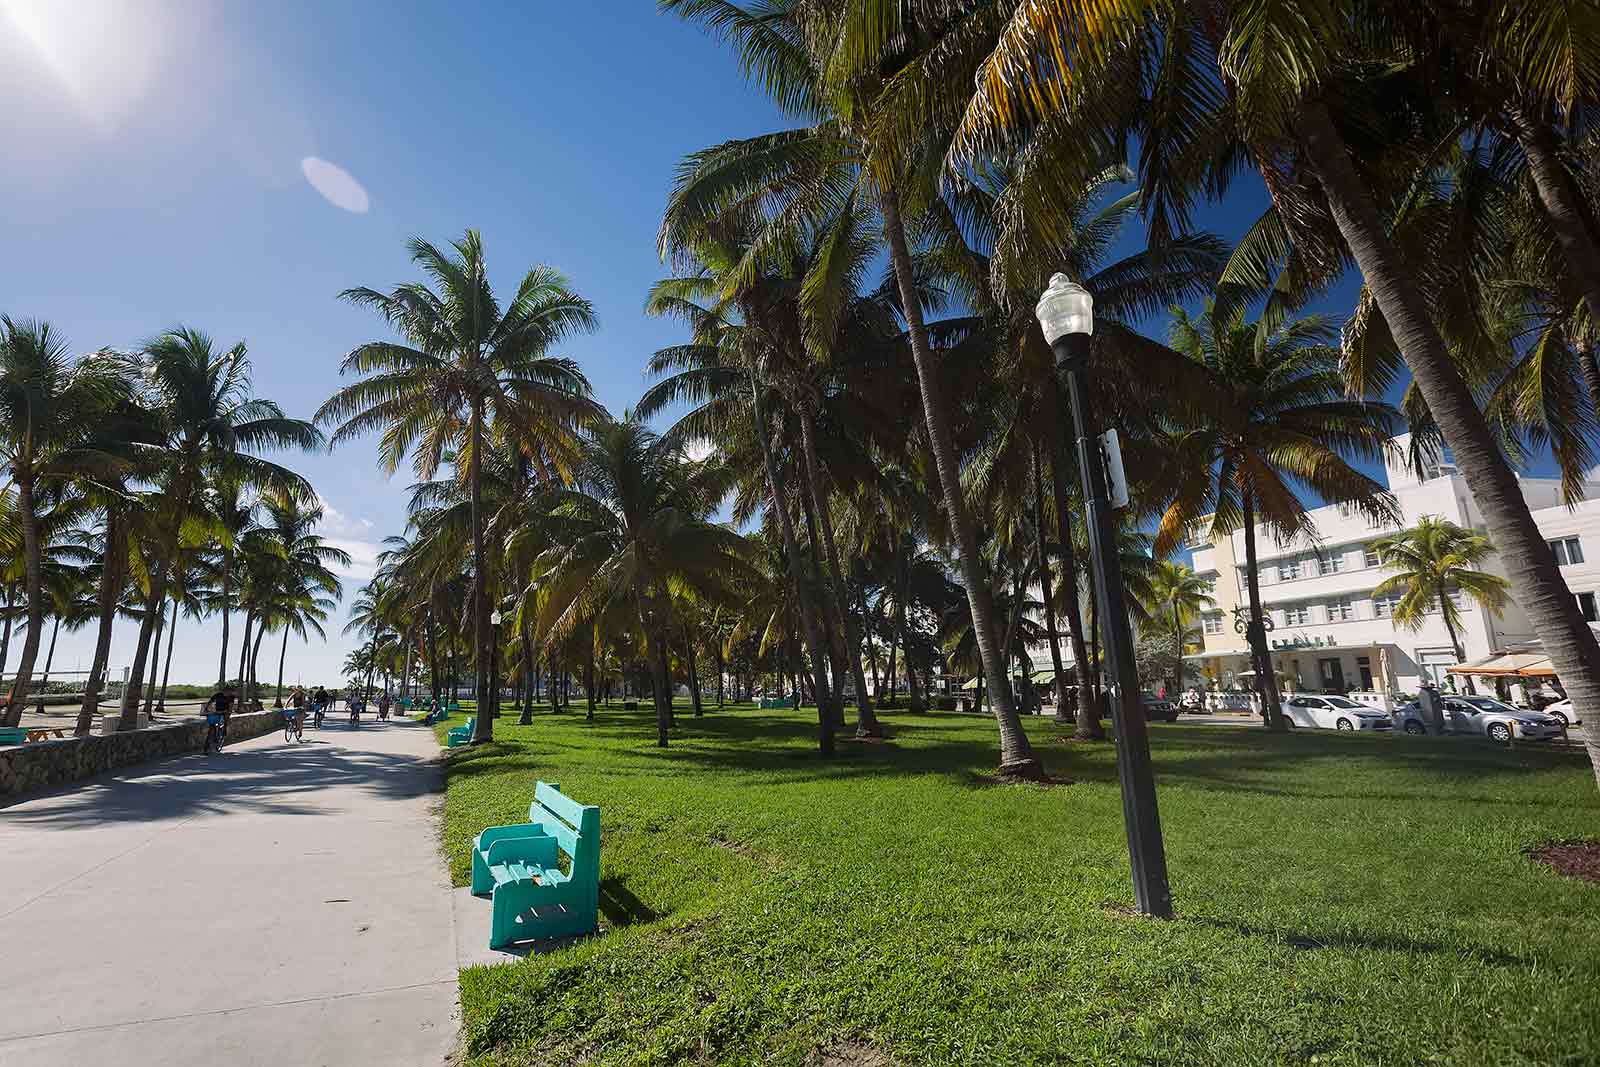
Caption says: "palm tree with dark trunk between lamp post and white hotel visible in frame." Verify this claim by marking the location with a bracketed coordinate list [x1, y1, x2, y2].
[1152, 299, 1398, 729]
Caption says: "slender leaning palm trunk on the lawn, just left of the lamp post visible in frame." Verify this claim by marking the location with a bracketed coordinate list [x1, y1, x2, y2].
[880, 189, 1045, 777]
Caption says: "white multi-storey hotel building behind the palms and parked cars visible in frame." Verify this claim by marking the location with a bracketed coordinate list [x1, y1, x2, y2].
[1187, 437, 1600, 693]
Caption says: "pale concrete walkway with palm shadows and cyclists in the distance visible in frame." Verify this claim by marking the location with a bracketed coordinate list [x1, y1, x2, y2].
[0, 718, 456, 1067]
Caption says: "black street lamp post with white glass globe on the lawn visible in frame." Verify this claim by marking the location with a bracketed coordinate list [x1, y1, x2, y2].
[1034, 274, 1173, 918]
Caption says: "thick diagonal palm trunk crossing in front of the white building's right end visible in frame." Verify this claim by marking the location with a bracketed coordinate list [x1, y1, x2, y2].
[1301, 104, 1600, 784]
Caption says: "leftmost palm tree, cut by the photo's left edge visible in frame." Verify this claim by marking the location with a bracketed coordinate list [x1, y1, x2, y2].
[0, 317, 126, 726]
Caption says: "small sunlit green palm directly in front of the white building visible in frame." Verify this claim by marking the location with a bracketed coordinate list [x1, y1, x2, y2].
[1373, 515, 1510, 662]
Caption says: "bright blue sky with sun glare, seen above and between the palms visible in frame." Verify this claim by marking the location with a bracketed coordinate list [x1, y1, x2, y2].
[0, 0, 1548, 681]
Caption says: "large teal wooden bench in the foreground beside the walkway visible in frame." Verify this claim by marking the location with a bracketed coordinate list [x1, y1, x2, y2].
[472, 782, 600, 949]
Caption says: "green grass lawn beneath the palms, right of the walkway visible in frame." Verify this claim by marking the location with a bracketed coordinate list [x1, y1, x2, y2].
[440, 705, 1600, 1065]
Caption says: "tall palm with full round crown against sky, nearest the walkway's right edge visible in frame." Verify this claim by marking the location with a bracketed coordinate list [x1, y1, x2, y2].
[317, 230, 597, 739]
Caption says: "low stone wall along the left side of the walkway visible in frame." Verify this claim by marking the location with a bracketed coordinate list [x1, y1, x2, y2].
[0, 710, 283, 800]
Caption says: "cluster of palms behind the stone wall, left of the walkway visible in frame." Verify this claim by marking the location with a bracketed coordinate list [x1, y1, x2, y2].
[0, 318, 340, 736]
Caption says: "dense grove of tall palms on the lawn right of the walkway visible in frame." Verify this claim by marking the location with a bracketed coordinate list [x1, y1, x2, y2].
[318, 0, 1600, 790]
